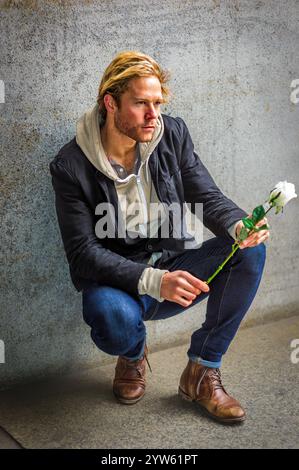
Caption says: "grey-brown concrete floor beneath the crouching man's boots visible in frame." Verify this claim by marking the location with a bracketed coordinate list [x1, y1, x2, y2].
[0, 316, 299, 449]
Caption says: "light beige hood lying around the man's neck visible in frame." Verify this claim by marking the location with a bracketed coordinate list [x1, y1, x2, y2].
[76, 104, 164, 182]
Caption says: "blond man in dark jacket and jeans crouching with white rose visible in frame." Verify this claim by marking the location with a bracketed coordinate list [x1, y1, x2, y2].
[50, 51, 269, 423]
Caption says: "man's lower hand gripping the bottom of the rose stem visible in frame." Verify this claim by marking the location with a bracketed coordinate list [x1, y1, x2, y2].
[160, 271, 210, 307]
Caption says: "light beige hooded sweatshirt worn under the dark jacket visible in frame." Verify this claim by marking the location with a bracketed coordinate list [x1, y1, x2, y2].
[76, 104, 169, 302]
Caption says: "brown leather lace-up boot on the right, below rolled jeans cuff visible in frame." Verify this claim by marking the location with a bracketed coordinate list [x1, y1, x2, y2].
[179, 360, 246, 423]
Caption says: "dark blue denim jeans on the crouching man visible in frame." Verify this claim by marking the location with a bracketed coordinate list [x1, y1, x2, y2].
[82, 237, 266, 367]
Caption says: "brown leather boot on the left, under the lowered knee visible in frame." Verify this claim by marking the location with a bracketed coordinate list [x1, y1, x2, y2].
[113, 345, 152, 405]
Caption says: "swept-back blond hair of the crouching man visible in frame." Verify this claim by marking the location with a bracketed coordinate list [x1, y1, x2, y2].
[97, 51, 170, 123]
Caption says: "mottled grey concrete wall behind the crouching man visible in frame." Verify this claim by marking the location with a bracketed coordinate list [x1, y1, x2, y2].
[0, 0, 299, 387]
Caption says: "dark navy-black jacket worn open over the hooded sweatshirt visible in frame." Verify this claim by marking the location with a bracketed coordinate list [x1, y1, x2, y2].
[50, 114, 248, 294]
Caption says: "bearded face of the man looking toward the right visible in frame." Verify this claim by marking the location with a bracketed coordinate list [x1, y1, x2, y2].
[114, 76, 163, 142]
